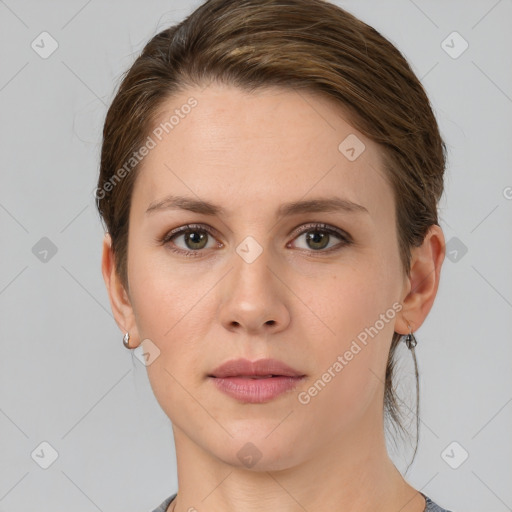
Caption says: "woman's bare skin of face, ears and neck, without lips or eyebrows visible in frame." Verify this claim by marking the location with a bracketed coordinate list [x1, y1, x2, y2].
[102, 84, 444, 512]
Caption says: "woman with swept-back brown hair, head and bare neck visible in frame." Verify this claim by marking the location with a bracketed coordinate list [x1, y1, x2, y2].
[97, 0, 446, 512]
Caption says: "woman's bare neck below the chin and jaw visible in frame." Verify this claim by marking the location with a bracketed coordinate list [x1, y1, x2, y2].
[170, 404, 425, 512]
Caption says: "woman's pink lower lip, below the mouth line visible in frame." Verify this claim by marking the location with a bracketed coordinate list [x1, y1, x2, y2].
[208, 376, 304, 404]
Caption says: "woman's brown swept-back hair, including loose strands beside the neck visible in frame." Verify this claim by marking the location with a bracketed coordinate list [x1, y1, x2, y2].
[96, 0, 446, 468]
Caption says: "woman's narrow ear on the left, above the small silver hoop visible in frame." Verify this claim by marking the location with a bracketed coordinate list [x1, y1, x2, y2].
[101, 233, 140, 348]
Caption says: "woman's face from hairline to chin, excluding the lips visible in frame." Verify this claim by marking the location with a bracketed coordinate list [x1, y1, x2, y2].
[120, 85, 405, 469]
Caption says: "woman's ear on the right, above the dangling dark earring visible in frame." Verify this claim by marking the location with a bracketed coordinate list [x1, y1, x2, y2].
[395, 224, 446, 334]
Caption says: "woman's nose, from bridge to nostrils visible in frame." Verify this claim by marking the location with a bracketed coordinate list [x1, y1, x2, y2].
[219, 244, 291, 336]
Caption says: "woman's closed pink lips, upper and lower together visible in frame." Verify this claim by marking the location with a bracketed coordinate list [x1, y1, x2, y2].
[208, 359, 305, 403]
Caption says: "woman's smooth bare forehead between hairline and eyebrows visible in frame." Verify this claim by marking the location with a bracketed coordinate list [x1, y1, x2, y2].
[133, 85, 392, 220]
